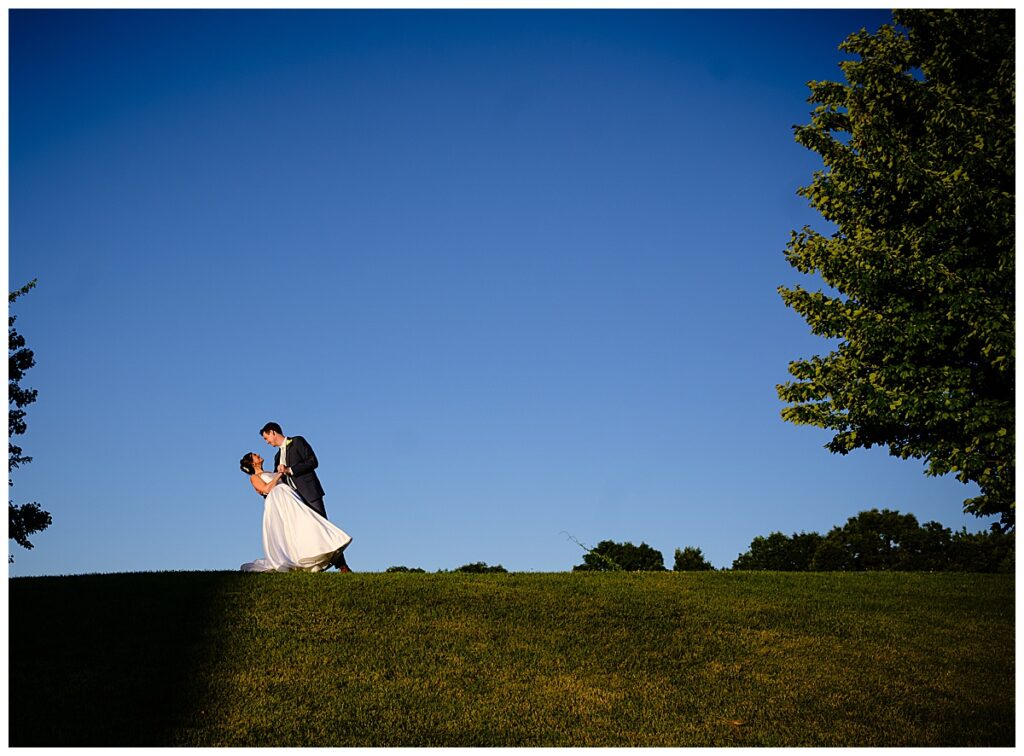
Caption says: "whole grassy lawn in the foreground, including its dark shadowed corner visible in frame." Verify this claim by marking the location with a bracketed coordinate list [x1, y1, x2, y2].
[9, 573, 1015, 747]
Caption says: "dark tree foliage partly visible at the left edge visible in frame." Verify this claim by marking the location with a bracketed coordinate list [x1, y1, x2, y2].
[7, 281, 52, 561]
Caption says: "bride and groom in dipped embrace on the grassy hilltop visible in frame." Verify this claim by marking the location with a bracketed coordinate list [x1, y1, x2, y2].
[241, 423, 352, 573]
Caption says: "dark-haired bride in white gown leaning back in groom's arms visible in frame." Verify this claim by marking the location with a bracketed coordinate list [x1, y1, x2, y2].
[241, 452, 352, 573]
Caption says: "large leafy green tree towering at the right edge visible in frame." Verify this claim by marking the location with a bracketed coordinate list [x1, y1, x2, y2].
[778, 10, 1015, 527]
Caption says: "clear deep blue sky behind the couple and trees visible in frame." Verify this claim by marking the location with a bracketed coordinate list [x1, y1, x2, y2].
[9, 9, 993, 576]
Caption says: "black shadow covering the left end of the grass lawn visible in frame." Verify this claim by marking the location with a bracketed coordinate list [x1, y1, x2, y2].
[8, 572, 245, 747]
